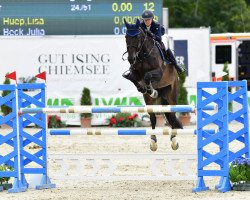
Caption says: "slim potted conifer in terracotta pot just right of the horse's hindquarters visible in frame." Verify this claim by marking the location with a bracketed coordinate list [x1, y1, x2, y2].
[178, 73, 191, 126]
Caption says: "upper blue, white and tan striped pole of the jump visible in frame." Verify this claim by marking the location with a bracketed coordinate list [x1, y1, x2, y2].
[20, 105, 217, 114]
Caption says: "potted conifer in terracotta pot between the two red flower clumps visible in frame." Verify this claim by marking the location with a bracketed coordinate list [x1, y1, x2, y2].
[80, 87, 92, 128]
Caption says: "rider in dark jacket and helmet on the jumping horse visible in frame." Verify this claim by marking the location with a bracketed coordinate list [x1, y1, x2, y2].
[141, 10, 186, 74]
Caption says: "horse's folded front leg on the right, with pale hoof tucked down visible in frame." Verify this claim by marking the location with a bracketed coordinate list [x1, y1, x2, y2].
[144, 70, 162, 98]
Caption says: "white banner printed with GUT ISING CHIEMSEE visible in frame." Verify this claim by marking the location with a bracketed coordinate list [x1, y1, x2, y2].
[0, 36, 135, 93]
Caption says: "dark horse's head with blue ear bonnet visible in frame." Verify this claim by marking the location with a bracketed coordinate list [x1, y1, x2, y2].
[124, 19, 145, 65]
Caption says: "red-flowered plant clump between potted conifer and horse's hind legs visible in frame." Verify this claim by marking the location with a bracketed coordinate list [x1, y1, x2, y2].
[108, 112, 141, 127]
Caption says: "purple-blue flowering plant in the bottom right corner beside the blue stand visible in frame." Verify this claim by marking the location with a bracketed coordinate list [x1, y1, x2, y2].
[229, 158, 250, 191]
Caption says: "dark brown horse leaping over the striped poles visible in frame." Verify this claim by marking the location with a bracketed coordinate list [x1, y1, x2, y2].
[123, 19, 183, 151]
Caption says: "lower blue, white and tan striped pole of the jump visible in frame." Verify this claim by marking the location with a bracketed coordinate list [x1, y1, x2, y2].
[48, 128, 201, 136]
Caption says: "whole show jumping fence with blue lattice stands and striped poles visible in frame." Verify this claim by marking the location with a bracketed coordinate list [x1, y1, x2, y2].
[0, 81, 249, 192]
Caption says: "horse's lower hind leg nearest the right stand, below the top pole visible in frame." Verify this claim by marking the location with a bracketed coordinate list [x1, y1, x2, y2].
[164, 113, 183, 150]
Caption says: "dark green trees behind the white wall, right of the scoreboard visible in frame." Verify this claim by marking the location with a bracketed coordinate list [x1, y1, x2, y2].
[163, 0, 250, 33]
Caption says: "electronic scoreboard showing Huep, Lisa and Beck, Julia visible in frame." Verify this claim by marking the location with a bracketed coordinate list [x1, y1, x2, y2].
[0, 0, 162, 36]
